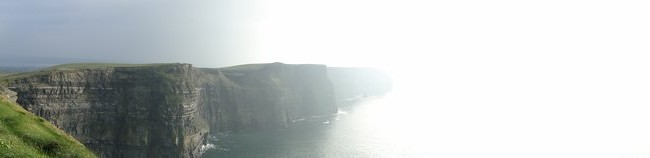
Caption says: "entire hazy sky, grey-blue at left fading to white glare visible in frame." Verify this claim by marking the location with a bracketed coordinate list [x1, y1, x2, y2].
[0, 0, 650, 68]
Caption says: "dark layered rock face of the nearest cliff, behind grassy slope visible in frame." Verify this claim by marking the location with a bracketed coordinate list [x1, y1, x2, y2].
[10, 64, 207, 157]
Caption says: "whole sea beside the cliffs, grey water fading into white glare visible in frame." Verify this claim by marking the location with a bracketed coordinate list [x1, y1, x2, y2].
[204, 65, 650, 158]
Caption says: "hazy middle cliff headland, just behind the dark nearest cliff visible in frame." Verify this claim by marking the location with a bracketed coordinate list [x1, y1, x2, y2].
[202, 63, 337, 131]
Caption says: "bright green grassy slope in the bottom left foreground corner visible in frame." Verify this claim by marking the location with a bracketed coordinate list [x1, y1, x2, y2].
[0, 97, 96, 157]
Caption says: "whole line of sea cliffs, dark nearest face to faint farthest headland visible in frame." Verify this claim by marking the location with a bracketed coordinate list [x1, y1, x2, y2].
[0, 63, 386, 157]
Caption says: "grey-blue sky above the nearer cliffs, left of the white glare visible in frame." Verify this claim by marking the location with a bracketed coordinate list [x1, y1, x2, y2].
[0, 0, 255, 66]
